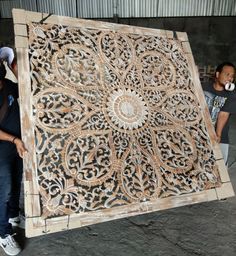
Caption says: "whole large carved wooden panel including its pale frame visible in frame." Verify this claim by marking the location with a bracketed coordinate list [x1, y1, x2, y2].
[13, 10, 233, 236]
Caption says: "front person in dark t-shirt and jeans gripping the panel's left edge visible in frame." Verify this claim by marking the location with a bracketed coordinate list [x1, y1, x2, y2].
[0, 61, 26, 255]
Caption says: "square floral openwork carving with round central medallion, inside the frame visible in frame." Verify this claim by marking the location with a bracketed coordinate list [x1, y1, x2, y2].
[28, 23, 220, 218]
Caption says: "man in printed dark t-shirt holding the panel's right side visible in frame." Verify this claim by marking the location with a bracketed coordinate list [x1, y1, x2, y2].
[203, 62, 236, 165]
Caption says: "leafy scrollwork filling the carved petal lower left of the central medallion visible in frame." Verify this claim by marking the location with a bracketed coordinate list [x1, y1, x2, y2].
[65, 135, 112, 184]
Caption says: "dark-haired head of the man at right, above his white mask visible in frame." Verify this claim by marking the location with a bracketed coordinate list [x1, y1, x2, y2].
[215, 62, 235, 90]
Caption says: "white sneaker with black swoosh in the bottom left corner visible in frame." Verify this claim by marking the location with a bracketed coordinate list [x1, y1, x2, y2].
[0, 234, 21, 256]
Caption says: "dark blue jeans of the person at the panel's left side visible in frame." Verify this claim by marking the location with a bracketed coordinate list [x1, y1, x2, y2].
[0, 153, 23, 237]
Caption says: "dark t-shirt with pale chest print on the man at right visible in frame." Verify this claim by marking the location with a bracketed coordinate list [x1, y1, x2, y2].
[202, 81, 236, 144]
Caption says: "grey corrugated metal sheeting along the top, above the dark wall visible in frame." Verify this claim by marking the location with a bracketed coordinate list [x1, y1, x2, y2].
[0, 0, 236, 18]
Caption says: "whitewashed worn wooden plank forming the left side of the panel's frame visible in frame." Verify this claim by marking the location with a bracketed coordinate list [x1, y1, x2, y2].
[17, 45, 41, 220]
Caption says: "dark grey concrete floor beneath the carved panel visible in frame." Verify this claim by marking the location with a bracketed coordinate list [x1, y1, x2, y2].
[0, 116, 236, 256]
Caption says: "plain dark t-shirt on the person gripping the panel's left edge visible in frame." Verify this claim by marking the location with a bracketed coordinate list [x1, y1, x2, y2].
[0, 79, 21, 160]
